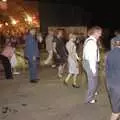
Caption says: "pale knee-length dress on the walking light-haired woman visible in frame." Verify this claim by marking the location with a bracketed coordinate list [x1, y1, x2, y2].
[66, 41, 79, 75]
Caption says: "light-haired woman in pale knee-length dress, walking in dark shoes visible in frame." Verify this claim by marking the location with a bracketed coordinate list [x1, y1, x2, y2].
[64, 34, 80, 88]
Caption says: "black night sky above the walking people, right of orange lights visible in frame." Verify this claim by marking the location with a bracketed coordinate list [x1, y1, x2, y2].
[26, 0, 120, 48]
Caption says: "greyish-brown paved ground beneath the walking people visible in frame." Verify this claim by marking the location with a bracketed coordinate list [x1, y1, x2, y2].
[0, 67, 111, 120]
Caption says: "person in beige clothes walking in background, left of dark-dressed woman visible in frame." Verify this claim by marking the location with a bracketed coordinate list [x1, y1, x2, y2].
[44, 30, 54, 64]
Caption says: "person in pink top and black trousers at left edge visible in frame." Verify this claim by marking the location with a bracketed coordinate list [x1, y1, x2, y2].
[0, 42, 14, 79]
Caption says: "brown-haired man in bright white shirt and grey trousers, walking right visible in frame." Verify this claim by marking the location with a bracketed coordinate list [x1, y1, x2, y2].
[83, 26, 102, 103]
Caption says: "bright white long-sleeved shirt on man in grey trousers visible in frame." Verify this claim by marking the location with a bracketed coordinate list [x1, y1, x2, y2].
[83, 36, 99, 74]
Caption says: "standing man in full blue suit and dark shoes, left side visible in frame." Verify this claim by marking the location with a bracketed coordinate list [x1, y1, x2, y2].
[25, 28, 40, 83]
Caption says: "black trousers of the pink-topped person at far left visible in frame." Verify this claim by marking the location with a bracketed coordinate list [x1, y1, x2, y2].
[0, 55, 13, 79]
